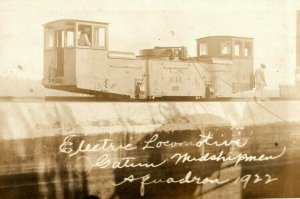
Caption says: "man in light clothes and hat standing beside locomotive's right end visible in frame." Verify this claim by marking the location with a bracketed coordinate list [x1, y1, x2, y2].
[254, 64, 267, 100]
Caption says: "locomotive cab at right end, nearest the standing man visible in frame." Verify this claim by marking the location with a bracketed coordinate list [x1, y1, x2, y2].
[197, 36, 254, 97]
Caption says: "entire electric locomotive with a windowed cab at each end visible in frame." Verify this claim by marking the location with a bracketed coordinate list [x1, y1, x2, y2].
[43, 20, 253, 99]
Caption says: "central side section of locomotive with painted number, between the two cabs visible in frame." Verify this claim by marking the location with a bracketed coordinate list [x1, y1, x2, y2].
[148, 60, 205, 97]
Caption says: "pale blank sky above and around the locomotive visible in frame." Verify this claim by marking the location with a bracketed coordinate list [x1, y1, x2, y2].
[0, 0, 300, 87]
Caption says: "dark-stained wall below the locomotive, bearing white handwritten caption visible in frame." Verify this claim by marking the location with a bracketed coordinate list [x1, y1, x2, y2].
[0, 102, 300, 199]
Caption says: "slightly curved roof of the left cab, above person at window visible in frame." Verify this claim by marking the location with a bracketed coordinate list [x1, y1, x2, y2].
[43, 19, 109, 28]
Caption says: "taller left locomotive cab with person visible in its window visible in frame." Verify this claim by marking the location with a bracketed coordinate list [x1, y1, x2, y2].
[43, 20, 108, 93]
